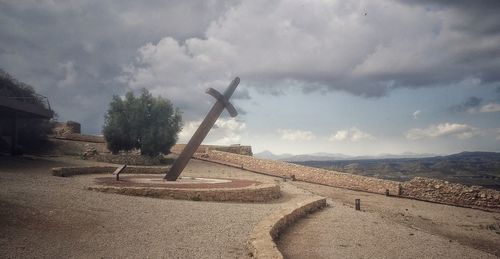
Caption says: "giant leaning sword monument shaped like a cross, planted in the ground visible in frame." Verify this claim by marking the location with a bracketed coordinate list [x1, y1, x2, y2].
[165, 77, 240, 181]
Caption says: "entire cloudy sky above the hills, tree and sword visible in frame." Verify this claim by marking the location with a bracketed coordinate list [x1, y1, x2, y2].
[0, 0, 500, 155]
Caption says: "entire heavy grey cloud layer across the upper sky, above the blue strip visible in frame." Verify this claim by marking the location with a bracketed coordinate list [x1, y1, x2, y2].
[0, 0, 500, 132]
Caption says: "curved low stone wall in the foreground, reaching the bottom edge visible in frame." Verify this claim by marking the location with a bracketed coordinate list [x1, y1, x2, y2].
[248, 197, 326, 259]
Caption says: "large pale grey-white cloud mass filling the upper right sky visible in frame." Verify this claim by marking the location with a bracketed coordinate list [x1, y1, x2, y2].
[120, 1, 500, 102]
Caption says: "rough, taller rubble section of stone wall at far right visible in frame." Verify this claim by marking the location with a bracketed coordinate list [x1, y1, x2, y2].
[401, 177, 500, 211]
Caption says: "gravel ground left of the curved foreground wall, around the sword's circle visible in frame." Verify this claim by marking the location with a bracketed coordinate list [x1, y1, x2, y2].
[0, 157, 310, 258]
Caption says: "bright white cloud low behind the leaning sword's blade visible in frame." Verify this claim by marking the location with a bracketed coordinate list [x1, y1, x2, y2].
[178, 118, 246, 145]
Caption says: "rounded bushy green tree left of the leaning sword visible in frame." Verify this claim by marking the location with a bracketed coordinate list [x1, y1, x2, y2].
[103, 89, 182, 156]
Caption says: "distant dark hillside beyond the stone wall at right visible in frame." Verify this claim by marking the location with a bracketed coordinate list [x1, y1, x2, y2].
[293, 152, 500, 190]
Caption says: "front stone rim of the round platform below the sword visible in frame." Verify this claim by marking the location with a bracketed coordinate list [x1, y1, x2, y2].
[87, 183, 281, 202]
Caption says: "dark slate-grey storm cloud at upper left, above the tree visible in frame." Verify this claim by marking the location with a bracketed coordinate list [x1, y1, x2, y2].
[0, 0, 237, 133]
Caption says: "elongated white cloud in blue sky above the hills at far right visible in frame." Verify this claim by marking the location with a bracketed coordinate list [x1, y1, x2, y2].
[406, 123, 479, 140]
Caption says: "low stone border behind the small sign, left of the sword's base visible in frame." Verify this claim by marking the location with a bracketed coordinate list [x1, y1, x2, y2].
[52, 166, 170, 177]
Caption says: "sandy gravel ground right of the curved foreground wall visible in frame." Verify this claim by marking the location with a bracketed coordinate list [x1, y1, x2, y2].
[278, 182, 500, 258]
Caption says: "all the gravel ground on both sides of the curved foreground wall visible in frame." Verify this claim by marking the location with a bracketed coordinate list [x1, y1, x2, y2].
[5, 156, 500, 258]
